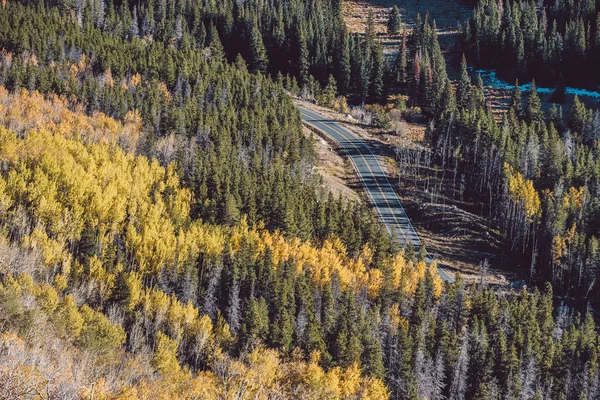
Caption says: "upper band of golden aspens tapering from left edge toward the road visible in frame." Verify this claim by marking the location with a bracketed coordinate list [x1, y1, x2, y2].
[0, 88, 426, 300]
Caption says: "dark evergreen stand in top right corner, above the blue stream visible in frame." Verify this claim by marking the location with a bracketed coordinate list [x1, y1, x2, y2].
[463, 0, 600, 87]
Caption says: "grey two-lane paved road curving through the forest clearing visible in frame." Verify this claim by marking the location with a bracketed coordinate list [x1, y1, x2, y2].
[298, 106, 454, 283]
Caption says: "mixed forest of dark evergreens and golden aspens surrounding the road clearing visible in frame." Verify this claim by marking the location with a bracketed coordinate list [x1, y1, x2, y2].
[0, 0, 600, 400]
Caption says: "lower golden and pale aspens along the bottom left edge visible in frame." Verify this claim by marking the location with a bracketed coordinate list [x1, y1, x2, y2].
[0, 266, 389, 400]
